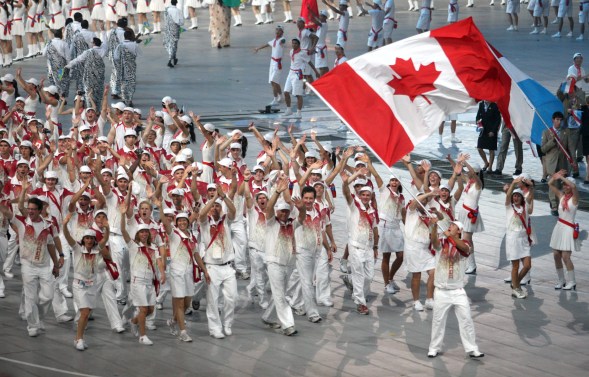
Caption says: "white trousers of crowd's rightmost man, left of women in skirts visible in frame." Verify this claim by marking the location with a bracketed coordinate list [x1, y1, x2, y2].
[348, 244, 374, 305]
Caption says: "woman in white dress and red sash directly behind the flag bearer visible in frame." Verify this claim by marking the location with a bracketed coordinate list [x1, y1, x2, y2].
[456, 161, 485, 274]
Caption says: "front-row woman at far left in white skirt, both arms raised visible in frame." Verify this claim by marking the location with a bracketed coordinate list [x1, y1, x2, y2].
[62, 213, 111, 351]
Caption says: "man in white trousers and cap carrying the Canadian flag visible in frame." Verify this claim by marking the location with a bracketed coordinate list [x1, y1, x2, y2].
[427, 218, 485, 358]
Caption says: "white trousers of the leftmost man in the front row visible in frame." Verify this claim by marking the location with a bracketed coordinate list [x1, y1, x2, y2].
[22, 260, 55, 330]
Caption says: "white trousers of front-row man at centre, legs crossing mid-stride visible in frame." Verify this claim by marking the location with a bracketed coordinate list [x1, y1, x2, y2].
[262, 262, 294, 329]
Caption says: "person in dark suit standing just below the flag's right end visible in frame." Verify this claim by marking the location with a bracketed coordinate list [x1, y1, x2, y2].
[476, 101, 501, 171]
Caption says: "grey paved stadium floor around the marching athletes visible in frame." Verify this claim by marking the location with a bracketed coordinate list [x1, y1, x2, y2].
[0, 0, 589, 377]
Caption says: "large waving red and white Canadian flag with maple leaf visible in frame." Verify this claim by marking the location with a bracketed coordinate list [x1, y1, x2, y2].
[312, 18, 511, 166]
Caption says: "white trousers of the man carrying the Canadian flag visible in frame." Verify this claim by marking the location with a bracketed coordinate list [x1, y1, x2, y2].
[429, 288, 479, 353]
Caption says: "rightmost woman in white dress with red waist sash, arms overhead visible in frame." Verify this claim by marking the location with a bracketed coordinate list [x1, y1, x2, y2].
[548, 170, 580, 291]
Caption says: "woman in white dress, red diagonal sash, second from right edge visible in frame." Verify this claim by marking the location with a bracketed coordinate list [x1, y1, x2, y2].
[505, 177, 534, 298]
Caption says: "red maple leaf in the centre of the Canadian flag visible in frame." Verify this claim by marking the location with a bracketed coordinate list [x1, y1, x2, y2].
[387, 58, 441, 104]
